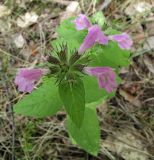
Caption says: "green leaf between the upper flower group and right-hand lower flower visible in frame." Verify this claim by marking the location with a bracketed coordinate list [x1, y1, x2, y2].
[90, 41, 130, 68]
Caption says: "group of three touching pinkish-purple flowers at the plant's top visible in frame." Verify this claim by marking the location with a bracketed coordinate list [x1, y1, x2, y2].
[74, 14, 133, 53]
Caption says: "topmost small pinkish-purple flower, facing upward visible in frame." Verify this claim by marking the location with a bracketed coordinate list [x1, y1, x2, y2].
[73, 14, 91, 30]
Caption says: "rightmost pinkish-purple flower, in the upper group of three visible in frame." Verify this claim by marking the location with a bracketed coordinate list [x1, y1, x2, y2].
[109, 33, 133, 49]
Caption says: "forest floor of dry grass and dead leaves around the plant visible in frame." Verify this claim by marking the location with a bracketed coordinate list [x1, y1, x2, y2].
[0, 0, 154, 160]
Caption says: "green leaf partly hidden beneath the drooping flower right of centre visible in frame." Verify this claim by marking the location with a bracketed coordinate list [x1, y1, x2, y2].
[82, 76, 115, 103]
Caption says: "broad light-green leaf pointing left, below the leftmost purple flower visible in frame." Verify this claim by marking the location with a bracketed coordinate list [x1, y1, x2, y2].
[14, 79, 62, 117]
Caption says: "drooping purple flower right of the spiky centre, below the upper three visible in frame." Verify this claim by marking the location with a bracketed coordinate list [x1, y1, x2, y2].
[84, 67, 117, 93]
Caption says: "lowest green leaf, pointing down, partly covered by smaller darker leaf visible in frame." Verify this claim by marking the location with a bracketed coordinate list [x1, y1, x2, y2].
[66, 106, 100, 156]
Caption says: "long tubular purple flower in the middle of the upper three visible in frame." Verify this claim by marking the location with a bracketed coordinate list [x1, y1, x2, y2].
[79, 25, 108, 54]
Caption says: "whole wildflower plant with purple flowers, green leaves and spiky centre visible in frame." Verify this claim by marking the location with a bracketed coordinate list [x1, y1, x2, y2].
[14, 12, 132, 156]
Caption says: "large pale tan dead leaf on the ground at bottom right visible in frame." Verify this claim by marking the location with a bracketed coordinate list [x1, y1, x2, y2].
[101, 128, 148, 160]
